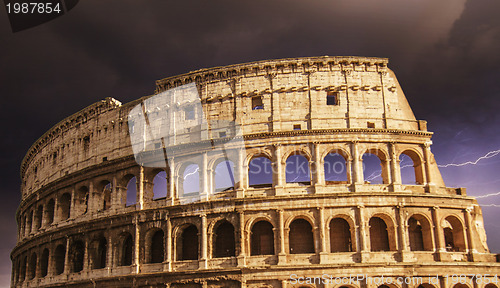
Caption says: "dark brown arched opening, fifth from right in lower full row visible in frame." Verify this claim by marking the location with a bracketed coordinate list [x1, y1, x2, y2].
[288, 219, 314, 254]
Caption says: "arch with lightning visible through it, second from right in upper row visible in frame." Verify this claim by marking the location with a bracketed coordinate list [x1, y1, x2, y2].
[360, 148, 390, 184]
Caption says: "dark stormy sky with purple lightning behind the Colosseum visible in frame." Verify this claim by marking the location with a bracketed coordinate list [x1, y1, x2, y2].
[0, 0, 500, 286]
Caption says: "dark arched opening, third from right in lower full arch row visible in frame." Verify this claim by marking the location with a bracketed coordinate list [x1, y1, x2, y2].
[368, 214, 397, 251]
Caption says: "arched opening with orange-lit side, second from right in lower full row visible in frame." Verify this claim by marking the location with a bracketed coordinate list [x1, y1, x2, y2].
[407, 214, 434, 251]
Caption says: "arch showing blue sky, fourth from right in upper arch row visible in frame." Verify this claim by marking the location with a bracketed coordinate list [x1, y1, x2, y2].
[284, 150, 312, 185]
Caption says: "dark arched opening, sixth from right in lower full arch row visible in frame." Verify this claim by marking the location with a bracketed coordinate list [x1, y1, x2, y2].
[250, 220, 274, 255]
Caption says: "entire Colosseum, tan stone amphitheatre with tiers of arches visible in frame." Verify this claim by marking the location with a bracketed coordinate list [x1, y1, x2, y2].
[11, 56, 500, 288]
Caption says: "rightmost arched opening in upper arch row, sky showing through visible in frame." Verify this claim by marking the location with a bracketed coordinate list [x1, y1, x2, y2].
[399, 150, 424, 185]
